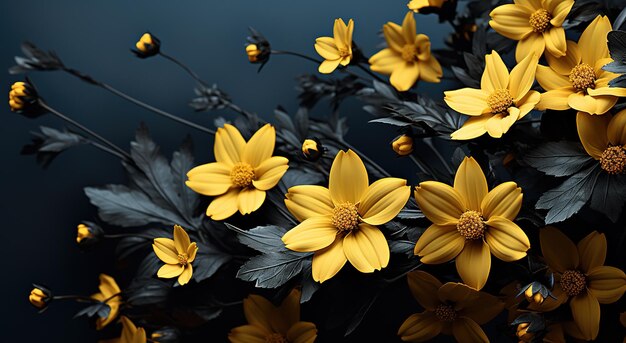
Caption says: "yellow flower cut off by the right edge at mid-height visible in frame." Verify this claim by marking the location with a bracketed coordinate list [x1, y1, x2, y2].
[576, 110, 626, 174]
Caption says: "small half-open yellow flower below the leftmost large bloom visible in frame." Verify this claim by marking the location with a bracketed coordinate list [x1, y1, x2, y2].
[152, 225, 198, 286]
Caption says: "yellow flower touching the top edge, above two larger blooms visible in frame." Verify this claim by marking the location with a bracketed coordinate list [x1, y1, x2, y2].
[489, 0, 574, 62]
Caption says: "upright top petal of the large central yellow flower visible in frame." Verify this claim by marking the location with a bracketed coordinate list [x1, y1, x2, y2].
[328, 150, 369, 204]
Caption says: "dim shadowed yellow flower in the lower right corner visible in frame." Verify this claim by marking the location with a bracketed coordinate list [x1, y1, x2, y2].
[539, 227, 626, 340]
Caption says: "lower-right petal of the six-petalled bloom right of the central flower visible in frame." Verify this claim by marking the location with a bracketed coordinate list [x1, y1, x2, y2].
[485, 216, 530, 262]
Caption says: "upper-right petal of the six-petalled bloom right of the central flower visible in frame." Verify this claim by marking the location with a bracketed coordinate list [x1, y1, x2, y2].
[480, 181, 522, 220]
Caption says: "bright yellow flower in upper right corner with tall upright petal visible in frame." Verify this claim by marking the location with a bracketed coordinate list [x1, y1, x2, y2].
[537, 16, 626, 114]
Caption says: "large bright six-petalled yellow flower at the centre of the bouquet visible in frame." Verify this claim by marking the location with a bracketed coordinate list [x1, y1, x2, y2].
[283, 150, 411, 282]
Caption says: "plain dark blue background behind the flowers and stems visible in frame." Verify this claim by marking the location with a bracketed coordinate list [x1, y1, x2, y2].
[0, 0, 449, 342]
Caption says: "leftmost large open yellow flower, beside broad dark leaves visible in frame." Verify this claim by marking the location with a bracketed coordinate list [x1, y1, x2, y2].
[186, 124, 289, 220]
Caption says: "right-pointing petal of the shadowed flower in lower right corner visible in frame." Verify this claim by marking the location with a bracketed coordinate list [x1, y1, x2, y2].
[587, 266, 626, 304]
